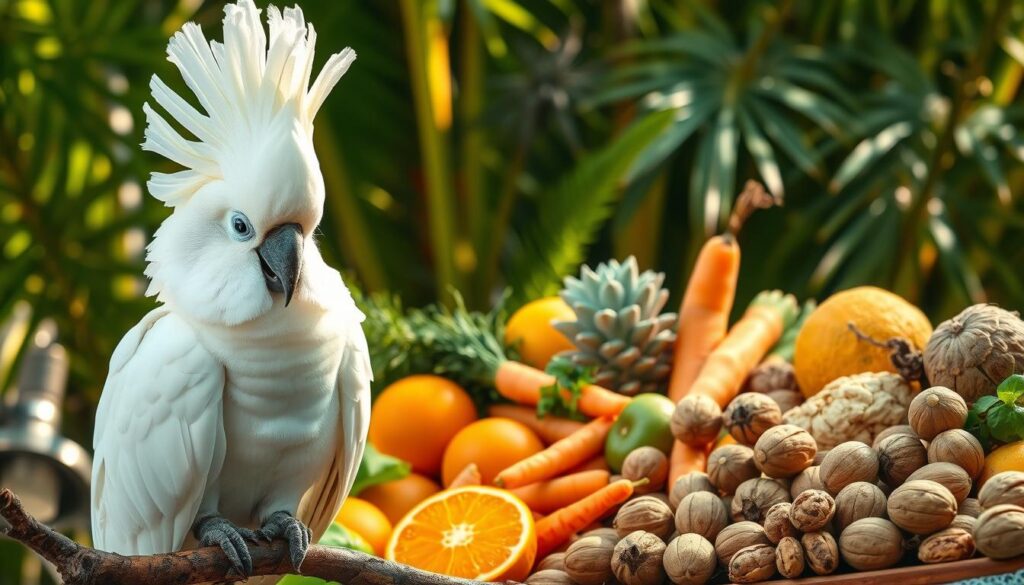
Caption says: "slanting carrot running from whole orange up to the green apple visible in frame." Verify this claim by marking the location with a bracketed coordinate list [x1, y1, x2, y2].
[495, 418, 614, 489]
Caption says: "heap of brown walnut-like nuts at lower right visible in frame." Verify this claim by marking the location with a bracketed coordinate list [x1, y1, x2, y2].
[527, 386, 1024, 585]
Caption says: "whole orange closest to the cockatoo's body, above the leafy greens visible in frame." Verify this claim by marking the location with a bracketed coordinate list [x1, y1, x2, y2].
[370, 375, 476, 475]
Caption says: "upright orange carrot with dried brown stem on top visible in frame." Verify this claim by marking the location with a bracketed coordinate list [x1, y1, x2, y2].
[669, 234, 739, 403]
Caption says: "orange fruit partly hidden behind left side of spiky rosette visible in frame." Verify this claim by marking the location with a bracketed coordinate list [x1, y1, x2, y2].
[505, 296, 575, 370]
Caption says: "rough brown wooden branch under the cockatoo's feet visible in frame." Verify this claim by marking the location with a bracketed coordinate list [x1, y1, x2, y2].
[0, 489, 512, 585]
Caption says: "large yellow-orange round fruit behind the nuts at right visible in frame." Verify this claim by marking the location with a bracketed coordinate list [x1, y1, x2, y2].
[794, 287, 932, 396]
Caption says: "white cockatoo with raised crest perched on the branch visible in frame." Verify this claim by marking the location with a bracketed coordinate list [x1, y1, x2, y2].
[92, 0, 372, 576]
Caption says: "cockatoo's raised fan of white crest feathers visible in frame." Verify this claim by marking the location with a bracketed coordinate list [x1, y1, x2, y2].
[142, 0, 355, 207]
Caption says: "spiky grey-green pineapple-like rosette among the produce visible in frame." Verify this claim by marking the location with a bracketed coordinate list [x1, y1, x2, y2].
[555, 256, 676, 396]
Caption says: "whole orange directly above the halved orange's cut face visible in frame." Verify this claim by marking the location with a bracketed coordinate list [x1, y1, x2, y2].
[441, 418, 544, 486]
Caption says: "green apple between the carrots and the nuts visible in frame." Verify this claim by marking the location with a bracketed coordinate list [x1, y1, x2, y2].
[604, 393, 676, 473]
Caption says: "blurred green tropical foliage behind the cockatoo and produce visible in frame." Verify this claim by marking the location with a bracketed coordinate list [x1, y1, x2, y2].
[0, 0, 1024, 584]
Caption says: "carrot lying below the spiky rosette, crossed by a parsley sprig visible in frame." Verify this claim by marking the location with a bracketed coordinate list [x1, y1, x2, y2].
[495, 361, 630, 417]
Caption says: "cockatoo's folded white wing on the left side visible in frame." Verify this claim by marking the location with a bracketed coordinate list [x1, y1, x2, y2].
[92, 308, 224, 554]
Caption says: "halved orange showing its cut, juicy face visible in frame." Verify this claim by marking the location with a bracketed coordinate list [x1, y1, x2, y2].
[385, 486, 537, 581]
